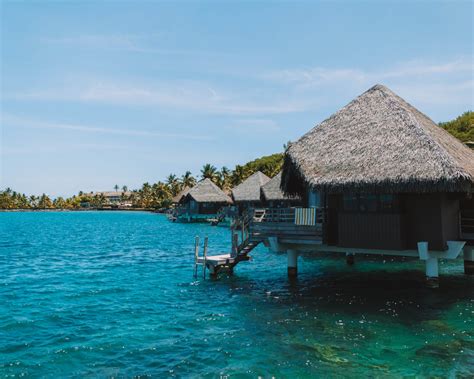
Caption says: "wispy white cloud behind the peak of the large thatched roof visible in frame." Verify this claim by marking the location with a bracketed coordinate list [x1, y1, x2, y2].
[260, 58, 474, 112]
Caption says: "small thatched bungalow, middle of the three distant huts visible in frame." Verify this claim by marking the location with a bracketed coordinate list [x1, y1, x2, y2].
[232, 171, 270, 212]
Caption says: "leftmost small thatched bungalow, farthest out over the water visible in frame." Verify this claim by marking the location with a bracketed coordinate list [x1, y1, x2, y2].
[174, 179, 232, 222]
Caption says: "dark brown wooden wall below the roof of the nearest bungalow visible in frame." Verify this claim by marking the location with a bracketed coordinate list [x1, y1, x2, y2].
[324, 194, 462, 250]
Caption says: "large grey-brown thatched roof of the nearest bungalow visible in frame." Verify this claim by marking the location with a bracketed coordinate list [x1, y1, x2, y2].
[282, 85, 474, 194]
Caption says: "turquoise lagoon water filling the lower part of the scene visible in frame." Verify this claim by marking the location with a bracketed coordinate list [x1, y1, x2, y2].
[0, 212, 474, 378]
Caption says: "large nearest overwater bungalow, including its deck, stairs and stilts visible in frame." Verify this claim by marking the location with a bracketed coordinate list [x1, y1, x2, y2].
[199, 85, 474, 286]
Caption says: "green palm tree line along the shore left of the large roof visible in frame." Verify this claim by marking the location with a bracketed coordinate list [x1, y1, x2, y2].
[0, 153, 283, 209]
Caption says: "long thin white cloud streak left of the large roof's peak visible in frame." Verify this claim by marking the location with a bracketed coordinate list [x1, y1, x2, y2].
[4, 81, 314, 115]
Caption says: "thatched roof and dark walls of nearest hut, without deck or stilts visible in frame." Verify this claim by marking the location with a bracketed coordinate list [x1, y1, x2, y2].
[281, 85, 474, 254]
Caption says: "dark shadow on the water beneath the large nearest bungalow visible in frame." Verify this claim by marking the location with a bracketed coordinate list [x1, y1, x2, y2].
[212, 262, 474, 326]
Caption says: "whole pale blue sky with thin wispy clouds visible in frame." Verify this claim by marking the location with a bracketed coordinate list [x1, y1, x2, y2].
[0, 1, 474, 196]
